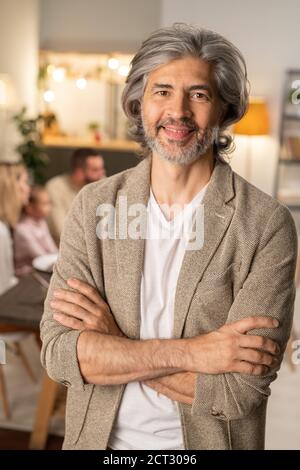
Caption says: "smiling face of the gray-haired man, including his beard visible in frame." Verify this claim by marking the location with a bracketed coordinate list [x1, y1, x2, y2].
[141, 57, 220, 165]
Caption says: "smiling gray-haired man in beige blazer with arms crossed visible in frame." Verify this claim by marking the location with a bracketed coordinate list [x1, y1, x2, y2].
[41, 24, 297, 450]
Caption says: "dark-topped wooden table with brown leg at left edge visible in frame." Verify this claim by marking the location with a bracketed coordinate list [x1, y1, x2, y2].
[0, 271, 63, 449]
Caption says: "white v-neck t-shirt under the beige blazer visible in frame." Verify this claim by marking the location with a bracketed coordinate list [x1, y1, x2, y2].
[109, 185, 207, 450]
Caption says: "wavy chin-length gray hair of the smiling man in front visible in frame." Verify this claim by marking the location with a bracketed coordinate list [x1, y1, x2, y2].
[122, 23, 249, 159]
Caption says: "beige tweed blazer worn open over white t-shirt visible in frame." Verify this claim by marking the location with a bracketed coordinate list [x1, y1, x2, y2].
[41, 158, 297, 450]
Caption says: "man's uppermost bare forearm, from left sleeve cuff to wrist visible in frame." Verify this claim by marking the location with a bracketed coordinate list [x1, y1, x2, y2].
[77, 330, 187, 385]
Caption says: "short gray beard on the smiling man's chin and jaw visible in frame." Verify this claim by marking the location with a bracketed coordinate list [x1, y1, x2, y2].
[144, 127, 219, 166]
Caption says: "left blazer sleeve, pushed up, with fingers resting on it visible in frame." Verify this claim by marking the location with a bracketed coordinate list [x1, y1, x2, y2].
[40, 185, 100, 391]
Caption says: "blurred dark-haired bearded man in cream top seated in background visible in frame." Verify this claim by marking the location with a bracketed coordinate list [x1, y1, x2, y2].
[46, 148, 106, 244]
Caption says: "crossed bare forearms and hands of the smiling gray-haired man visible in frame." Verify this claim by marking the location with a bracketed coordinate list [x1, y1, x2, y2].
[51, 279, 280, 404]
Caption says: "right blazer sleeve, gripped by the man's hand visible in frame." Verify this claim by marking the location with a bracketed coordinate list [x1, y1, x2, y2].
[192, 205, 297, 420]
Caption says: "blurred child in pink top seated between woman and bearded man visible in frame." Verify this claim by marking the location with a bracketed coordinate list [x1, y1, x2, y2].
[14, 186, 58, 276]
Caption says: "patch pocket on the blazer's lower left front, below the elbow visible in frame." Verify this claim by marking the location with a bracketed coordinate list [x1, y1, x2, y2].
[65, 384, 95, 445]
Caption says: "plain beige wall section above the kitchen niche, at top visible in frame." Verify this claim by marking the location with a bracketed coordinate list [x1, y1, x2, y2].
[40, 0, 161, 53]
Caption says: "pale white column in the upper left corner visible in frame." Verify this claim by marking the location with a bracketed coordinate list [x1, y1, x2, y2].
[0, 0, 39, 160]
